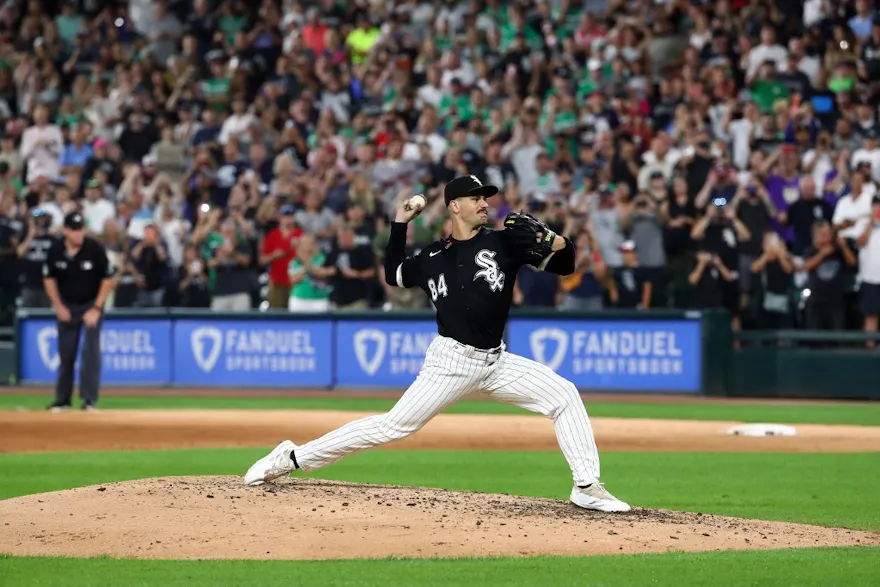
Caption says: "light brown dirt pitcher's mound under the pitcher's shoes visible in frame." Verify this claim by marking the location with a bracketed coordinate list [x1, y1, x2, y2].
[0, 477, 880, 559]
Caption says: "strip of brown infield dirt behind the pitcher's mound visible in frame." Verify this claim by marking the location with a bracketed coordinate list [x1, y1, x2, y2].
[0, 410, 880, 453]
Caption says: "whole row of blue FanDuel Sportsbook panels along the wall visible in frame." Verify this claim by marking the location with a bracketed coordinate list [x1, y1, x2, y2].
[16, 310, 706, 393]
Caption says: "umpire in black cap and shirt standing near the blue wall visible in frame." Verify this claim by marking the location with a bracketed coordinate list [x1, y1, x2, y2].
[43, 212, 113, 411]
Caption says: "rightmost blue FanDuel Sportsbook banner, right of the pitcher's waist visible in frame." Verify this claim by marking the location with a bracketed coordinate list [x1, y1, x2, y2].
[507, 319, 702, 393]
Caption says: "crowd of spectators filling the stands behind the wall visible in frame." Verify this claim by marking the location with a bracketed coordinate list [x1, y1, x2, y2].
[0, 0, 880, 344]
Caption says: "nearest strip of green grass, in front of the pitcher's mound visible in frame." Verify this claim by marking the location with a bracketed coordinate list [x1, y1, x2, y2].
[0, 548, 880, 587]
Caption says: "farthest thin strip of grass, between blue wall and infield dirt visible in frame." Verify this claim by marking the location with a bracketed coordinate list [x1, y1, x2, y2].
[0, 393, 880, 426]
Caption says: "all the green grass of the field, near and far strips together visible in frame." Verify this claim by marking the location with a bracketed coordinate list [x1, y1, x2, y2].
[0, 394, 880, 587]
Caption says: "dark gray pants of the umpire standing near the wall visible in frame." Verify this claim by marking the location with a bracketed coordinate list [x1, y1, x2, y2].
[55, 303, 101, 405]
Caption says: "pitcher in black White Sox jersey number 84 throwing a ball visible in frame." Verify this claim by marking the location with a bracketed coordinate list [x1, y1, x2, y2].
[244, 175, 630, 512]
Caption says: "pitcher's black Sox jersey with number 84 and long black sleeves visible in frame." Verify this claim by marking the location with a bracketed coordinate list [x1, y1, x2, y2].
[385, 222, 574, 349]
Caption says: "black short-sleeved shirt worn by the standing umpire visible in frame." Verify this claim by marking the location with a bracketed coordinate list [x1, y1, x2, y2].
[43, 237, 112, 305]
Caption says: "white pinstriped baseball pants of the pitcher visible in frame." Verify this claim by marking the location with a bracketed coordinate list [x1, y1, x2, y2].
[295, 336, 599, 486]
